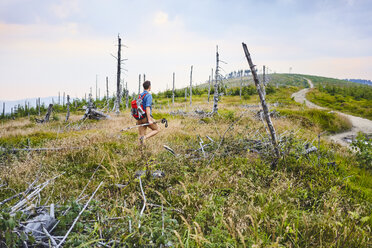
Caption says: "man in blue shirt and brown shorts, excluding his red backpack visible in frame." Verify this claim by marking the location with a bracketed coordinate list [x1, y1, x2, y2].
[137, 81, 159, 145]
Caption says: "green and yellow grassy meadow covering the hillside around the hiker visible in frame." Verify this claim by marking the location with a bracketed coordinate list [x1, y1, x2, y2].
[0, 74, 372, 247]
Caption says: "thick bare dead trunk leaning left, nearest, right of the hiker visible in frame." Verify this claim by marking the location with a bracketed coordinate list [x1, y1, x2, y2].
[242, 43, 280, 161]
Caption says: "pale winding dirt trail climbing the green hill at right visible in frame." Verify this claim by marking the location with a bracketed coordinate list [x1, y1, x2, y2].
[292, 78, 372, 146]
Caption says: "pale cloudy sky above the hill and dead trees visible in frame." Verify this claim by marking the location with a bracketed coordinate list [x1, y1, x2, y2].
[0, 0, 372, 101]
